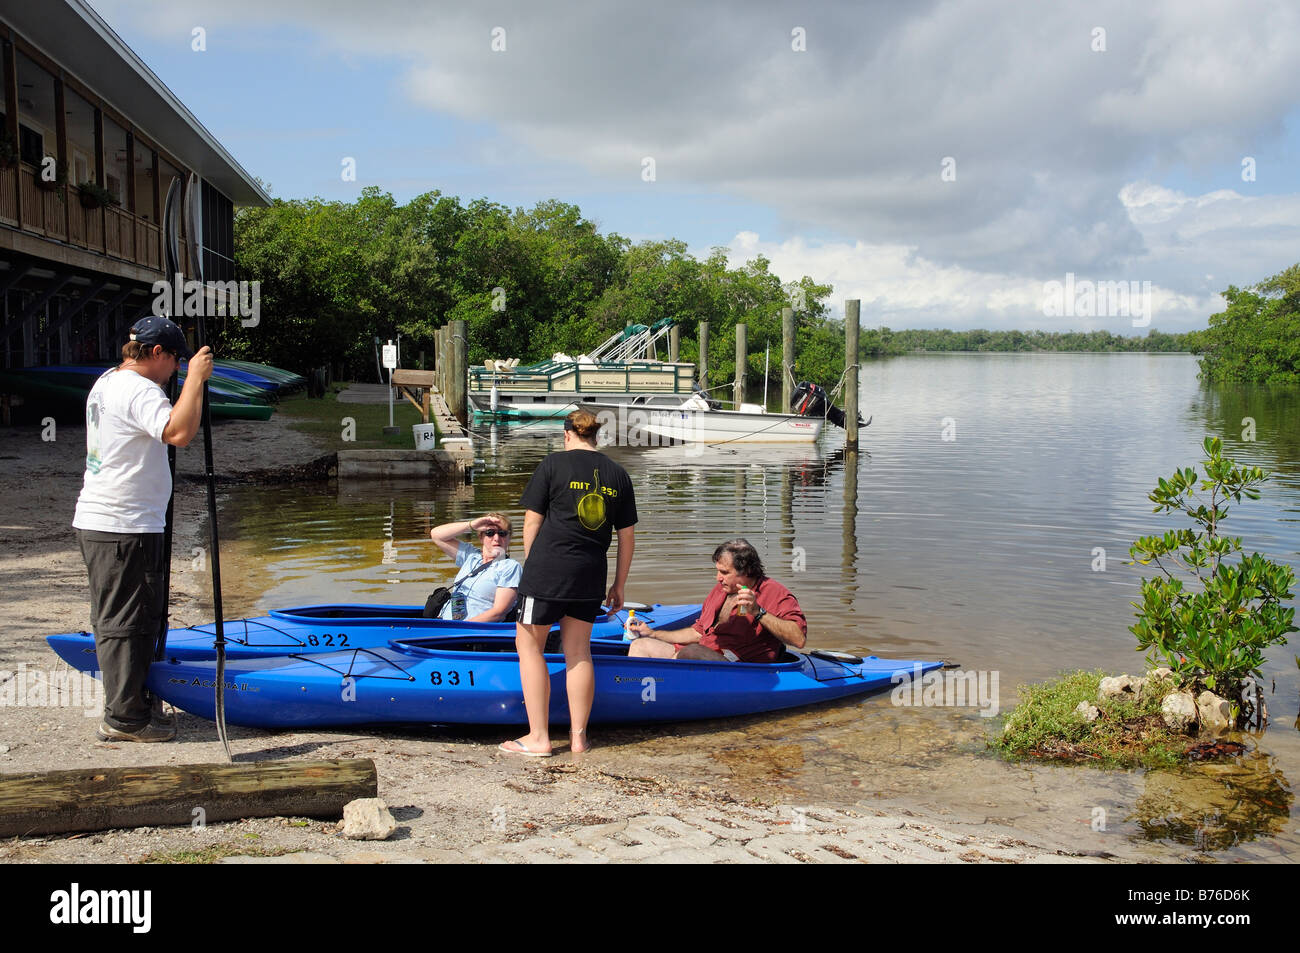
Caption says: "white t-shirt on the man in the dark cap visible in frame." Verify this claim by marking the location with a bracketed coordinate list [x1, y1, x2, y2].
[73, 369, 172, 533]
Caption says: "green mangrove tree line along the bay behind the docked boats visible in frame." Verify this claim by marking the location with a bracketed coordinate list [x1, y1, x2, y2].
[215, 187, 1300, 387]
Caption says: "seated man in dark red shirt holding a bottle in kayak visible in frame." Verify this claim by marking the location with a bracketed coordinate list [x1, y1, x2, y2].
[628, 540, 809, 662]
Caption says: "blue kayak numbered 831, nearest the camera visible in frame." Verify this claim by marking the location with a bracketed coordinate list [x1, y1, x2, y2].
[81, 634, 943, 728]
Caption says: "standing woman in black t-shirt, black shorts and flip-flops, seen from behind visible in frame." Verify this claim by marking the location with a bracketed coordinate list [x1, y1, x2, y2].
[501, 411, 637, 758]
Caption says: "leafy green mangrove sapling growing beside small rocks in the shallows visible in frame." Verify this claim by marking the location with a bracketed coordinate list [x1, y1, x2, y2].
[1128, 437, 1297, 724]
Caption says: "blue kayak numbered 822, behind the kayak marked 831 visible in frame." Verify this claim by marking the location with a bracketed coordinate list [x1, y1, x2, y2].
[46, 603, 701, 671]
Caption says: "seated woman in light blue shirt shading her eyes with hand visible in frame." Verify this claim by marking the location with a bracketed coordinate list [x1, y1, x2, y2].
[429, 512, 524, 621]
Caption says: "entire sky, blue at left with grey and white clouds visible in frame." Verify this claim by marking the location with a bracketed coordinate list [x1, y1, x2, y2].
[90, 0, 1300, 334]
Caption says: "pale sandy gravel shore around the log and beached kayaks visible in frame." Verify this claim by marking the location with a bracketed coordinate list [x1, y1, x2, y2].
[0, 416, 1100, 863]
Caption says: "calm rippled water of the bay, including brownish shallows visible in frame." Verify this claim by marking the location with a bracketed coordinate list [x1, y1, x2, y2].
[215, 355, 1300, 859]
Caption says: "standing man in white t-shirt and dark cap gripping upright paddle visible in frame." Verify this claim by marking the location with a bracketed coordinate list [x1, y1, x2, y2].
[73, 316, 212, 741]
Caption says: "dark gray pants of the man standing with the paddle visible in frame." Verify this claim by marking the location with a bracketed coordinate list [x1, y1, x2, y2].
[77, 529, 166, 731]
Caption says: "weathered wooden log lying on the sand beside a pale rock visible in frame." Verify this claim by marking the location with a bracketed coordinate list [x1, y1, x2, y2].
[0, 758, 378, 837]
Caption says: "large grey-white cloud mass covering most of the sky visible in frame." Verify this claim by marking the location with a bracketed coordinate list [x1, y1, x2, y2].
[96, 0, 1300, 326]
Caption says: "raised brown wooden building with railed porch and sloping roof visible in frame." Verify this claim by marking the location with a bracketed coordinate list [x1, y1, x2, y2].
[0, 0, 270, 368]
